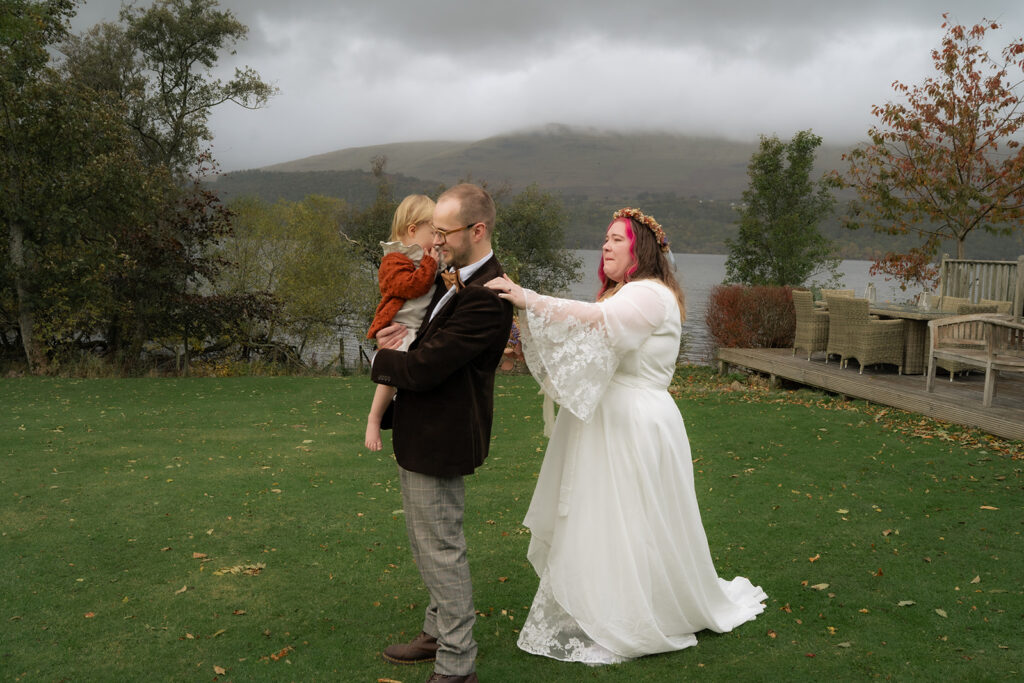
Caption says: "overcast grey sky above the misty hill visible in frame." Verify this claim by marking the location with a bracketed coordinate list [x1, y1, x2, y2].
[73, 0, 1024, 171]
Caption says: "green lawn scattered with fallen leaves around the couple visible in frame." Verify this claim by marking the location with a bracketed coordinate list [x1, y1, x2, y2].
[0, 373, 1024, 683]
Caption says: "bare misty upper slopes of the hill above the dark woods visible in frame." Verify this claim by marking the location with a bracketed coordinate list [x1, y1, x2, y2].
[253, 124, 845, 200]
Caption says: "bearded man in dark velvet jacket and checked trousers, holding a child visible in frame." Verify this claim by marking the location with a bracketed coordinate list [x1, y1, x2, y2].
[371, 184, 512, 683]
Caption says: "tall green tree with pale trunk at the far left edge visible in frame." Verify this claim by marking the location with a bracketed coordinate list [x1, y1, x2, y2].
[0, 0, 149, 372]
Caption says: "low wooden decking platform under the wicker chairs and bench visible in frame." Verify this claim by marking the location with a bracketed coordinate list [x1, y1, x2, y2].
[718, 348, 1024, 439]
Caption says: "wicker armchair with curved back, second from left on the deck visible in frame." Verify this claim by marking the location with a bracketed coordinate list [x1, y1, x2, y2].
[826, 297, 905, 374]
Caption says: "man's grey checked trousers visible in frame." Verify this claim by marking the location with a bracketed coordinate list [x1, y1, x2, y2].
[398, 467, 476, 676]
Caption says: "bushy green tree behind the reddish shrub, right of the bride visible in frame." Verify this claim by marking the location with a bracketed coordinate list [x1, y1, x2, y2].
[725, 130, 839, 286]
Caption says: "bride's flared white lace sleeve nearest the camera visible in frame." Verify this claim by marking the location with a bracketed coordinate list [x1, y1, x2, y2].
[521, 283, 666, 421]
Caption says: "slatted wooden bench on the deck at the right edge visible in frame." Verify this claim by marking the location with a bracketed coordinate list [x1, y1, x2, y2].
[926, 313, 1024, 408]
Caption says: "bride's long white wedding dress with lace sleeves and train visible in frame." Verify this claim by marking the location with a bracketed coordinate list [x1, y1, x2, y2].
[518, 280, 767, 665]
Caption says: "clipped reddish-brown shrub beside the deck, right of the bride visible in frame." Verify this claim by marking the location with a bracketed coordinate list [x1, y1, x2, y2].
[705, 285, 797, 348]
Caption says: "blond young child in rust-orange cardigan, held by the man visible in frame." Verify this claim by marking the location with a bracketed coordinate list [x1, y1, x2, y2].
[366, 195, 437, 451]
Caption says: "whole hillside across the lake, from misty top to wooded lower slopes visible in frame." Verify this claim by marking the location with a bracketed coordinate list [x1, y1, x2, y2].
[214, 125, 1024, 259]
